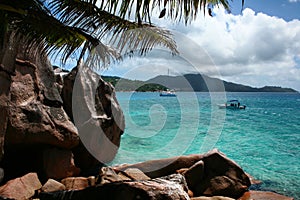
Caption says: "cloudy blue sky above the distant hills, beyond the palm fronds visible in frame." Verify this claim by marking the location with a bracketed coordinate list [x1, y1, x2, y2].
[101, 0, 300, 91]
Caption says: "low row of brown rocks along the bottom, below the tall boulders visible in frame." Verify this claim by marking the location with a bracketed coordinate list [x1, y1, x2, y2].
[0, 150, 291, 200]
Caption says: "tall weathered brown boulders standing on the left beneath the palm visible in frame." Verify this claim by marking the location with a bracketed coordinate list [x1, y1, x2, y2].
[0, 36, 124, 180]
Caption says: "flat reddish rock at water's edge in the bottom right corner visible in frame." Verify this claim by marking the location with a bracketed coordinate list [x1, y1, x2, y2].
[239, 190, 293, 200]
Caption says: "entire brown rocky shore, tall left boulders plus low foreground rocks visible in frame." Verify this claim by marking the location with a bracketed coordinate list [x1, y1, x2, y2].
[0, 45, 292, 200]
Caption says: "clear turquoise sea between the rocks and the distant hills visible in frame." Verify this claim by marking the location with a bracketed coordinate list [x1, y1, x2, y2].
[113, 92, 300, 199]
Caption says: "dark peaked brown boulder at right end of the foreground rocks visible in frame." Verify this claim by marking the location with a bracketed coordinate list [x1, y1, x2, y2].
[187, 149, 251, 198]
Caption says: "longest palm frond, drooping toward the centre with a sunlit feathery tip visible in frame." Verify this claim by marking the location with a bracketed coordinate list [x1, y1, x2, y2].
[50, 0, 177, 64]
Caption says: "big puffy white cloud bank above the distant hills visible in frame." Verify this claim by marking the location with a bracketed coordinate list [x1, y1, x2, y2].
[103, 8, 300, 91]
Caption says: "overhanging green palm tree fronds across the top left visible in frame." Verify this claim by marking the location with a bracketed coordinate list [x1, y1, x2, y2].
[0, 0, 243, 71]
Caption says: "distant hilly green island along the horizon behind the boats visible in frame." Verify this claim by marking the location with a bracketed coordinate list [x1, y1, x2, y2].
[102, 74, 298, 93]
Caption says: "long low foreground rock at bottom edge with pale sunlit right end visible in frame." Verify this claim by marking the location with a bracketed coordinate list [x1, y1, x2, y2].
[40, 176, 189, 200]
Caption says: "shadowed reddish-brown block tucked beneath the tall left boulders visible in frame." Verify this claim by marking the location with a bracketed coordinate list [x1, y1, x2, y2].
[43, 148, 80, 180]
